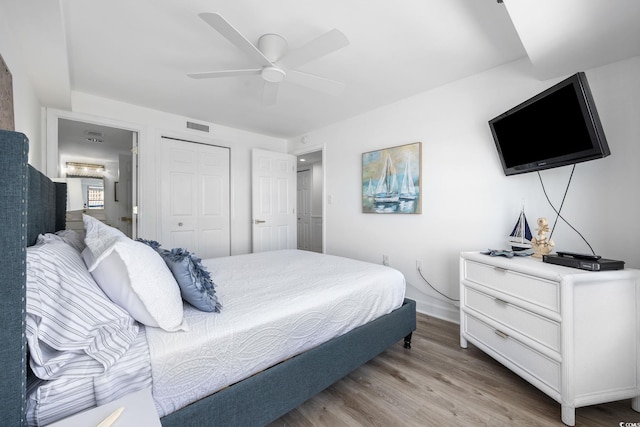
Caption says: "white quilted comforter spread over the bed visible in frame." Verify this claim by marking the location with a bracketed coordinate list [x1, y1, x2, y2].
[147, 250, 405, 416]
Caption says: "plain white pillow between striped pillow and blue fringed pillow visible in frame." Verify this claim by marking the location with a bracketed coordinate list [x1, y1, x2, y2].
[82, 216, 188, 331]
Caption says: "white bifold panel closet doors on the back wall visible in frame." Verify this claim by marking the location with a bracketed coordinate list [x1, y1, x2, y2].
[158, 137, 231, 259]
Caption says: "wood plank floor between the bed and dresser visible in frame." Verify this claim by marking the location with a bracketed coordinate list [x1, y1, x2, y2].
[269, 314, 640, 427]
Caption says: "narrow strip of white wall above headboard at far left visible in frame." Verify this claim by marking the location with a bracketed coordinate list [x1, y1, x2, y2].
[0, 4, 45, 170]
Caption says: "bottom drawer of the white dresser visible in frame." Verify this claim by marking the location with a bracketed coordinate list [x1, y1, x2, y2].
[463, 314, 561, 391]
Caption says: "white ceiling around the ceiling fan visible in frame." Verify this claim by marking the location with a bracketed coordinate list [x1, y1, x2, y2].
[0, 0, 640, 138]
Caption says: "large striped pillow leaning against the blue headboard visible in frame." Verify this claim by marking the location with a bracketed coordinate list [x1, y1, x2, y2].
[26, 240, 138, 379]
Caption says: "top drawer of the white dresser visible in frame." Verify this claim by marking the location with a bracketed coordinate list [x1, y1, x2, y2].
[463, 260, 560, 313]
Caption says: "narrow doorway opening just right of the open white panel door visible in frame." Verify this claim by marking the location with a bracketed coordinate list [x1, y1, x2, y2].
[297, 151, 324, 253]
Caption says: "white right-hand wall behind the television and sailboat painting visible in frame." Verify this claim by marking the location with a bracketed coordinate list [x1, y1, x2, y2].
[289, 57, 640, 321]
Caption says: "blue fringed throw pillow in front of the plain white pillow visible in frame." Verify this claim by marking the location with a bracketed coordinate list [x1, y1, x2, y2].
[158, 248, 222, 313]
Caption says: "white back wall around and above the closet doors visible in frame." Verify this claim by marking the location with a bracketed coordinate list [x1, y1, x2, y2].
[72, 92, 287, 254]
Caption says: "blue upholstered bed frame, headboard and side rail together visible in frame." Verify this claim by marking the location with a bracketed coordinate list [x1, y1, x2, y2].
[0, 131, 416, 426]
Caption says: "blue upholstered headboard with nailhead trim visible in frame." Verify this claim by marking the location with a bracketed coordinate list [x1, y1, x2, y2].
[0, 130, 67, 426]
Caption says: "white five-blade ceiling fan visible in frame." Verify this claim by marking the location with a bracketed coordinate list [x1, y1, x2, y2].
[187, 13, 349, 105]
